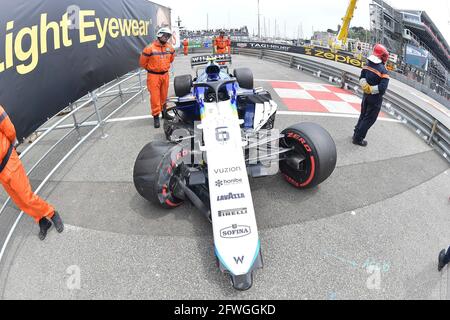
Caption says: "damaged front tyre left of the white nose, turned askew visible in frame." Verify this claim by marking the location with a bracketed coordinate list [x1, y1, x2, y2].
[133, 141, 190, 209]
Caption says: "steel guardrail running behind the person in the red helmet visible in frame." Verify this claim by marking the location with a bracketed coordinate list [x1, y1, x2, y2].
[233, 48, 450, 162]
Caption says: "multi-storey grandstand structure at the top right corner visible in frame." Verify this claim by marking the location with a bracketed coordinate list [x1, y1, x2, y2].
[370, 0, 450, 99]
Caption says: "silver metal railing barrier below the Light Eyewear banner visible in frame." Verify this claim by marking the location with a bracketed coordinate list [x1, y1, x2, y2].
[0, 70, 146, 267]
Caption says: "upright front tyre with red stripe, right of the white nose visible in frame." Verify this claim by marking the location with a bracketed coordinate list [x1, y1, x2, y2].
[280, 122, 337, 189]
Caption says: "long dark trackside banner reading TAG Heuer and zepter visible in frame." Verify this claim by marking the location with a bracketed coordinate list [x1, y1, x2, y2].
[231, 41, 364, 68]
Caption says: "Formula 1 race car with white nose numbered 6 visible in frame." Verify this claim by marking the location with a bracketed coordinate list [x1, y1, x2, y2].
[134, 55, 337, 290]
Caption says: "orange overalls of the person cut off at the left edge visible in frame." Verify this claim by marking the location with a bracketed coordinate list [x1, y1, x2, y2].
[0, 106, 55, 223]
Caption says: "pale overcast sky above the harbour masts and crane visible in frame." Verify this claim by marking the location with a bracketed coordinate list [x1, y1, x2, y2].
[154, 0, 450, 44]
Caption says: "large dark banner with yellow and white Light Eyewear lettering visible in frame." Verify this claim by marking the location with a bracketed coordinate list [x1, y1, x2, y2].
[0, 0, 171, 139]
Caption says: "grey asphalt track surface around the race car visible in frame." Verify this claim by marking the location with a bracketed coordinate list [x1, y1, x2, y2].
[0, 56, 450, 300]
